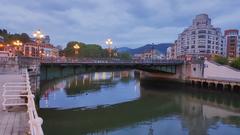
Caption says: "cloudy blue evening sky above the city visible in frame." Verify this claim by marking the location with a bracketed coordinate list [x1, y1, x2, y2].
[0, 0, 240, 48]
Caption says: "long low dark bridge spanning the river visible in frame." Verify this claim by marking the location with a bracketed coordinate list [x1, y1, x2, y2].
[0, 57, 184, 79]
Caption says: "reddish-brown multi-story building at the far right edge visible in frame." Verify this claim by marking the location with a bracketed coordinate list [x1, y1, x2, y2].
[224, 29, 239, 59]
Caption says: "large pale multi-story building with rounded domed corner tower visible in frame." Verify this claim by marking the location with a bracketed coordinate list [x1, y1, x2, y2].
[176, 14, 225, 58]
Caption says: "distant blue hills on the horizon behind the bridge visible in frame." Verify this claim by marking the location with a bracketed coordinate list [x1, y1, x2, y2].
[117, 43, 173, 55]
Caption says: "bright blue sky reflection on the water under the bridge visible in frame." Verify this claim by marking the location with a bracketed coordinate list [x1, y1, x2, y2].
[40, 71, 140, 109]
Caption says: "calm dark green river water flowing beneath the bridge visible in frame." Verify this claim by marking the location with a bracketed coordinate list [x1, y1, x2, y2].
[39, 71, 240, 135]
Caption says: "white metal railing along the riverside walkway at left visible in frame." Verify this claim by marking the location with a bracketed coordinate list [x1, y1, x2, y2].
[2, 70, 44, 135]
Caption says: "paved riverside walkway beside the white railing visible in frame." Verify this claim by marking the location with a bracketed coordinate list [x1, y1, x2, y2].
[0, 74, 28, 135]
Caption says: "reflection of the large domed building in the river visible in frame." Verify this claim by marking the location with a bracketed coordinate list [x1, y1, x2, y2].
[180, 93, 240, 135]
